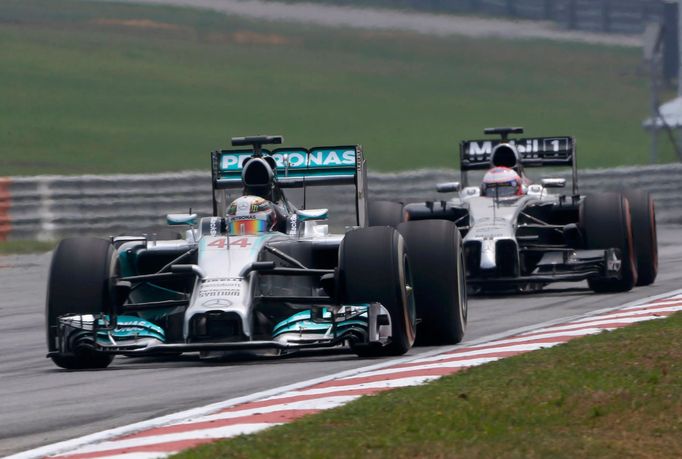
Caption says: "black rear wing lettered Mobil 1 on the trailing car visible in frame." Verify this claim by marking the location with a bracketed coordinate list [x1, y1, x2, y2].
[460, 132, 578, 194]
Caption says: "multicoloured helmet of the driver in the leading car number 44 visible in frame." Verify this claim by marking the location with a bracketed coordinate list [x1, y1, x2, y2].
[227, 196, 277, 236]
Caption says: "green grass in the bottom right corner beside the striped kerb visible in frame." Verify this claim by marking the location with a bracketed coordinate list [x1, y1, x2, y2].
[173, 314, 682, 459]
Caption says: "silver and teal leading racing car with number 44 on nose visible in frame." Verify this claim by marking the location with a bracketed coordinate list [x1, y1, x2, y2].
[46, 136, 467, 369]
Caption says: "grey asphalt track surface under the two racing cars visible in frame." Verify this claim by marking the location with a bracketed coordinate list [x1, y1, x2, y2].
[0, 227, 682, 456]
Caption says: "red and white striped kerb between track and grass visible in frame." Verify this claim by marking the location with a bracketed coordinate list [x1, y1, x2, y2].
[10, 294, 682, 459]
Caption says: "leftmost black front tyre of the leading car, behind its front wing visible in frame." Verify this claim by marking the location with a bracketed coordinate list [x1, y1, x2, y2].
[45, 238, 116, 369]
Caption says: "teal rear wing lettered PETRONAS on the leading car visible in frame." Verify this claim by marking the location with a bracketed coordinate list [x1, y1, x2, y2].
[211, 145, 367, 226]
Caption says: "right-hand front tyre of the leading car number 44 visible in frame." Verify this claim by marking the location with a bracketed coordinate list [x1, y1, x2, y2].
[337, 226, 416, 357]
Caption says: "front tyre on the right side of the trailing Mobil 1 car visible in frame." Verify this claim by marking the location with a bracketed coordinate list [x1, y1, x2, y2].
[580, 193, 637, 293]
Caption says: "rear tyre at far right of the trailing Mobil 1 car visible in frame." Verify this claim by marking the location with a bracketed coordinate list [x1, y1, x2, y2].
[625, 190, 658, 285]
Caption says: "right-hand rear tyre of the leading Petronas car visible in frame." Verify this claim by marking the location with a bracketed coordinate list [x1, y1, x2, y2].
[398, 220, 467, 345]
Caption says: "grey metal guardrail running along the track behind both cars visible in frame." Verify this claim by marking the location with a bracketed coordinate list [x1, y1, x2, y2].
[0, 164, 682, 240]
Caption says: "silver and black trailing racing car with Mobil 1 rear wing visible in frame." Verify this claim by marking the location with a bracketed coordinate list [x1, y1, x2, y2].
[369, 128, 658, 292]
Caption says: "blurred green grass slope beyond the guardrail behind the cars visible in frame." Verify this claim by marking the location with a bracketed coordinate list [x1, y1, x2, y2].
[0, 0, 673, 175]
